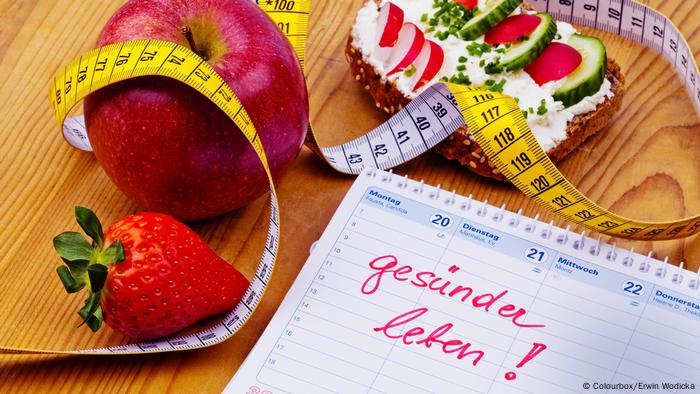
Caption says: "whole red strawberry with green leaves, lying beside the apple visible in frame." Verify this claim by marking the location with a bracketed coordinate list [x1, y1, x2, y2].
[53, 207, 249, 339]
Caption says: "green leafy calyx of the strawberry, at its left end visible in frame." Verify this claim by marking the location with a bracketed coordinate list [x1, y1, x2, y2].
[53, 207, 125, 331]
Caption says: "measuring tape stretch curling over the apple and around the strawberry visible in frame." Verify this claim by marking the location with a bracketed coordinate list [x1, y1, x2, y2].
[7, 40, 280, 354]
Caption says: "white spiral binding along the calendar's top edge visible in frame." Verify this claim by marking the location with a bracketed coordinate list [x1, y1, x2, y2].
[363, 167, 700, 290]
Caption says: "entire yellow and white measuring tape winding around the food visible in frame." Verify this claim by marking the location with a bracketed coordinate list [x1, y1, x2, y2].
[0, 0, 700, 354]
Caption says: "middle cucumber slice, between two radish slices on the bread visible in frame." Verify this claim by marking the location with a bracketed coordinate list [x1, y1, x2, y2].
[500, 12, 557, 71]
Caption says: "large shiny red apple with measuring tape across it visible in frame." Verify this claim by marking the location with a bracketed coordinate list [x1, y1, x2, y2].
[84, 0, 309, 220]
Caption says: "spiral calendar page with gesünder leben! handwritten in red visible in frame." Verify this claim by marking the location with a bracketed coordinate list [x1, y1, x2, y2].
[226, 169, 700, 394]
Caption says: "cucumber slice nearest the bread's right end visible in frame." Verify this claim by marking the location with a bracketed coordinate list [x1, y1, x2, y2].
[554, 34, 607, 107]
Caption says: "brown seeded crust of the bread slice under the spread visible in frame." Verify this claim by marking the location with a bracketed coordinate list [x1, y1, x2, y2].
[345, 14, 625, 181]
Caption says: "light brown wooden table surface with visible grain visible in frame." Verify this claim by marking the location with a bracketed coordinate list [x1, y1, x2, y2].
[0, 0, 700, 392]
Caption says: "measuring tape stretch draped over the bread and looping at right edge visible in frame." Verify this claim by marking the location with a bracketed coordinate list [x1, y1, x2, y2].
[284, 0, 700, 240]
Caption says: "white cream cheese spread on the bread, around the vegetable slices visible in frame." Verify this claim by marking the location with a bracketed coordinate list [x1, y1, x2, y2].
[352, 0, 613, 151]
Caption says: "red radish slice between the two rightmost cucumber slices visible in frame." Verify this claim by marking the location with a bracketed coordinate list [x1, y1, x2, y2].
[525, 42, 583, 86]
